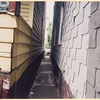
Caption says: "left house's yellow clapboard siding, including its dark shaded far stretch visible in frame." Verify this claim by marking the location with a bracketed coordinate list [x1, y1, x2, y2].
[0, 2, 45, 98]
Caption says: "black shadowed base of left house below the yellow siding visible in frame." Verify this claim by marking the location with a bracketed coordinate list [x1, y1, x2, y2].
[8, 53, 43, 98]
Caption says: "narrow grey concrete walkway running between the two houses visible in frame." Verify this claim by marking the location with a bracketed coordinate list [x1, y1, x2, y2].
[28, 56, 58, 99]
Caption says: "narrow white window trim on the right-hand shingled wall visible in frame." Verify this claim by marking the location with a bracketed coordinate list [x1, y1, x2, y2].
[58, 3, 64, 44]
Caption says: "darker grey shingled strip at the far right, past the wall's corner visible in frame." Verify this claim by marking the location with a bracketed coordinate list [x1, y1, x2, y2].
[86, 2, 100, 98]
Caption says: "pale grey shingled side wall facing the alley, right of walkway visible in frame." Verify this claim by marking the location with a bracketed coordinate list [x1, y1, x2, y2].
[52, 2, 91, 98]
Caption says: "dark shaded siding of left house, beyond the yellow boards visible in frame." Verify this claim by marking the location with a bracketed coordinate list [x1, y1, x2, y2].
[30, 2, 45, 63]
